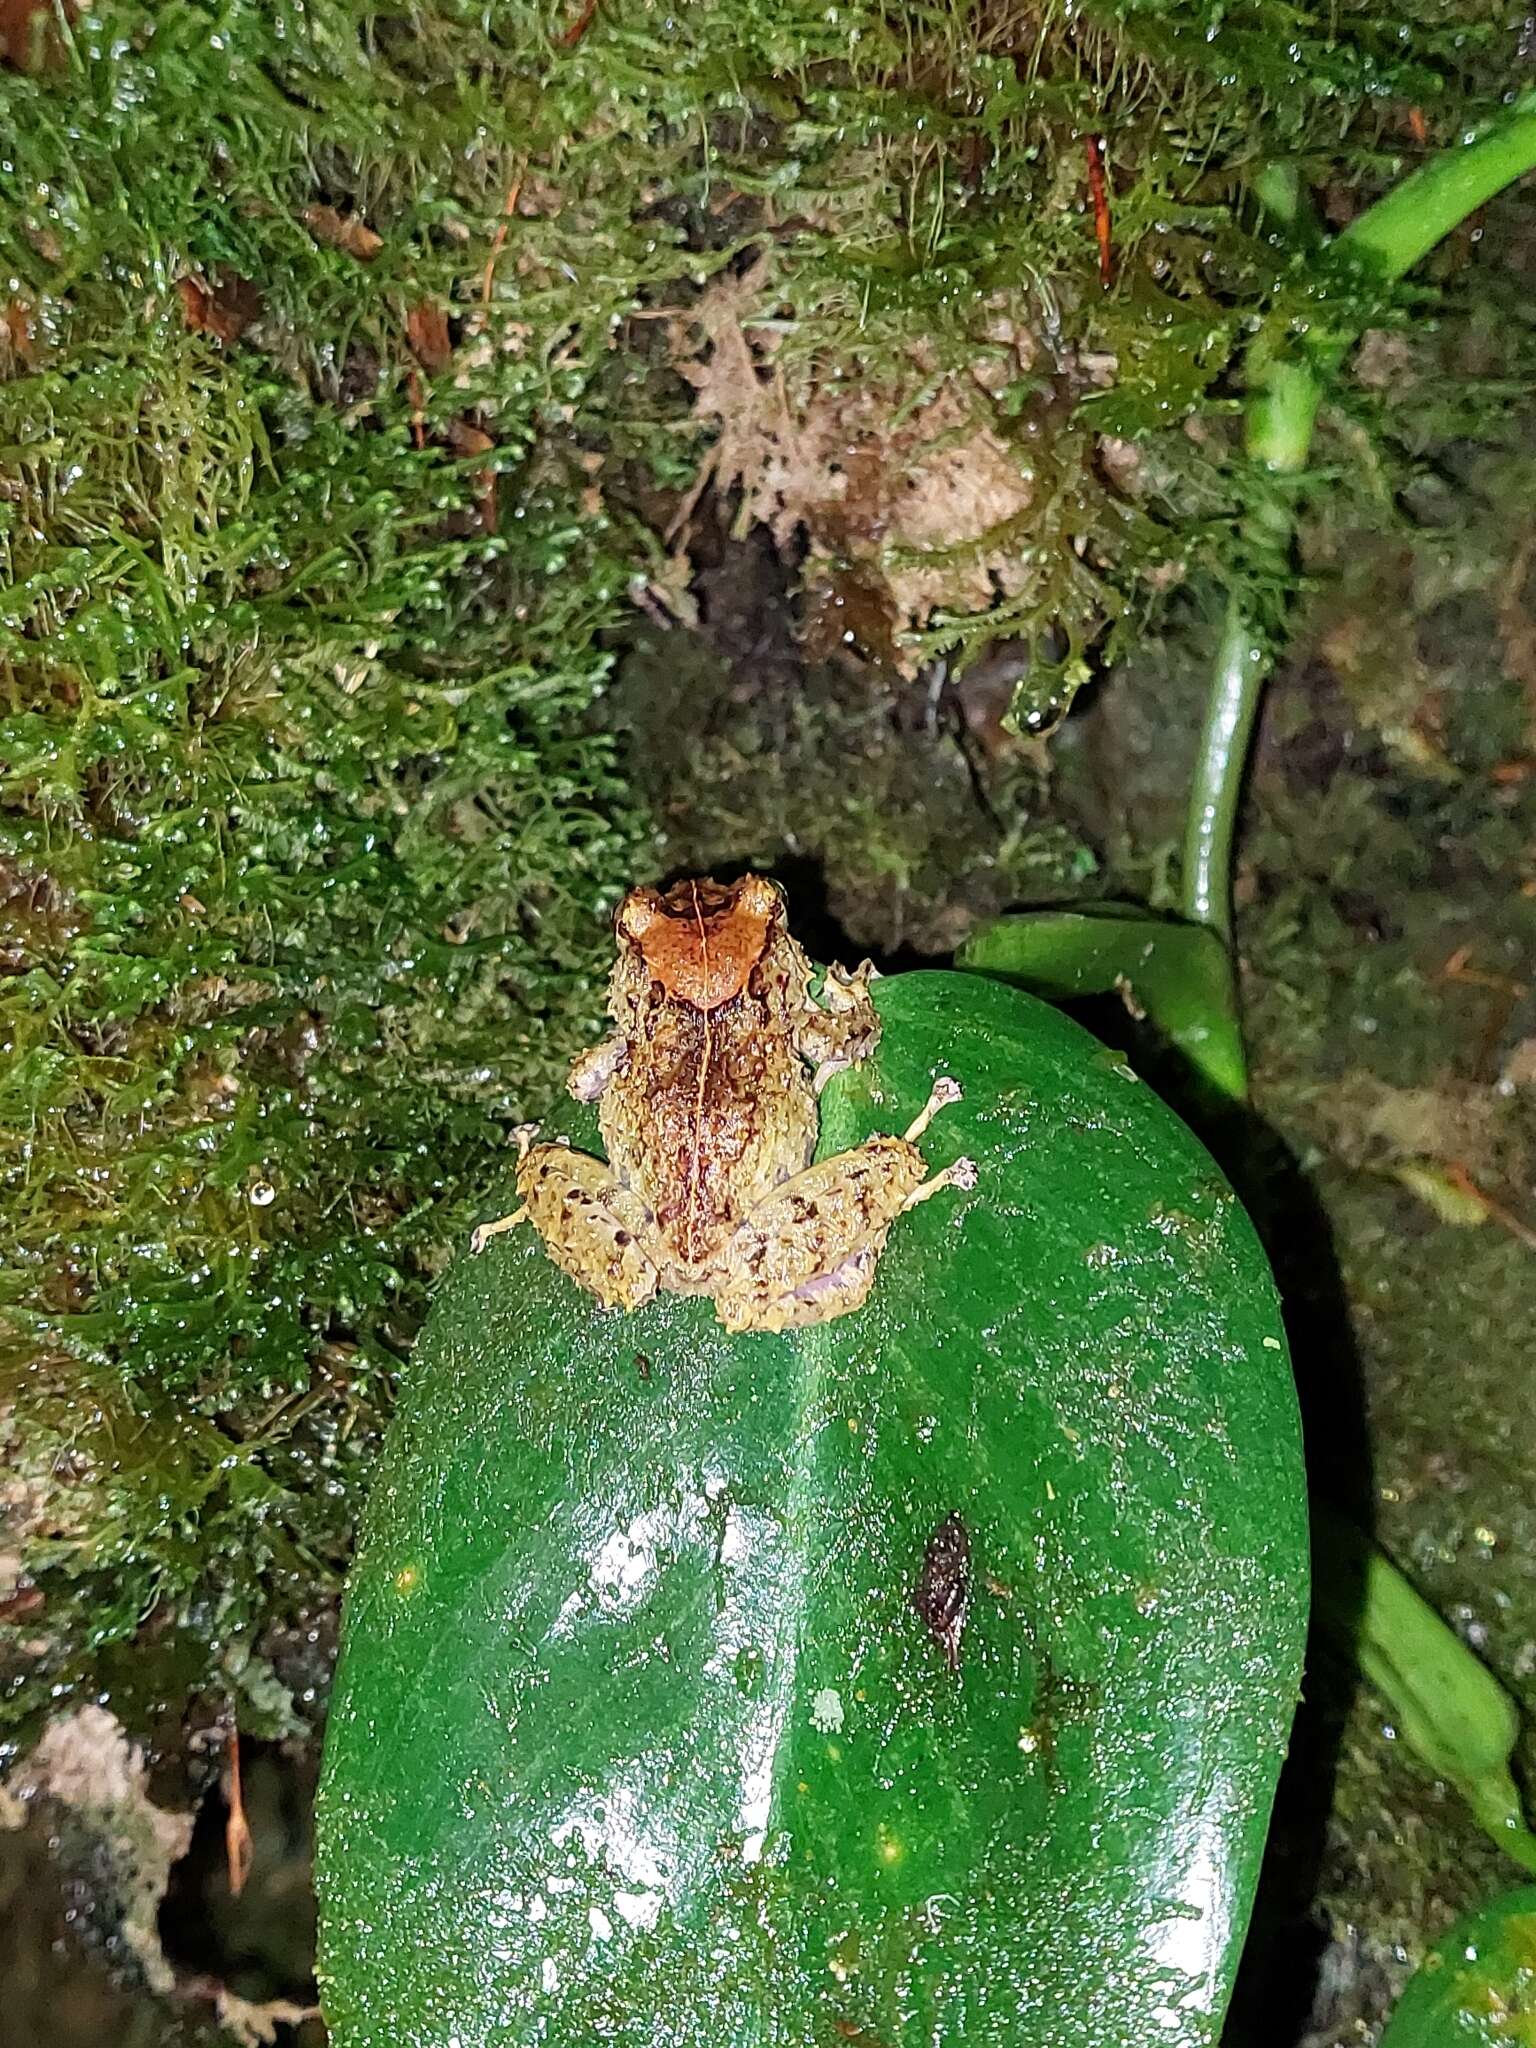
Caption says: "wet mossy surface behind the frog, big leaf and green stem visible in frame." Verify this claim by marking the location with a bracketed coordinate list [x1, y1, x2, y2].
[0, 0, 1536, 2038]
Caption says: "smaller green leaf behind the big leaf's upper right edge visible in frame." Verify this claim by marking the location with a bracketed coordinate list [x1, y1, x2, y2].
[958, 903, 1247, 1102]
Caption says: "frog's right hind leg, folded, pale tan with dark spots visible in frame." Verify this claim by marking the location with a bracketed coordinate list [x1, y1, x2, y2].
[715, 1079, 977, 1329]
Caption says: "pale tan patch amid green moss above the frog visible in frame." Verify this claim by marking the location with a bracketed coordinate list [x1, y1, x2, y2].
[670, 260, 1032, 674]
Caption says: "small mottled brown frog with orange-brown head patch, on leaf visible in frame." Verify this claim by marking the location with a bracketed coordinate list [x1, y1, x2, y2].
[469, 874, 977, 1331]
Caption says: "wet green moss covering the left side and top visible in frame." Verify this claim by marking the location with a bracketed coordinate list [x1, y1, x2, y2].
[0, 0, 1531, 1720]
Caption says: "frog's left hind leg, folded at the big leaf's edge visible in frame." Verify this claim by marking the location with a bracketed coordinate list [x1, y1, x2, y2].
[469, 1135, 657, 1309]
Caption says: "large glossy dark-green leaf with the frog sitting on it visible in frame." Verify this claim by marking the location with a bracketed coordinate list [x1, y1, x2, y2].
[319, 973, 1307, 2048]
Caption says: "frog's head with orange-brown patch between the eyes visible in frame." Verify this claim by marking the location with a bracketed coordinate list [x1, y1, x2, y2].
[614, 874, 786, 1010]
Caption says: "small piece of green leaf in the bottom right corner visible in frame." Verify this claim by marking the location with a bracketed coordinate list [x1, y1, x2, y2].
[1380, 1884, 1536, 2048]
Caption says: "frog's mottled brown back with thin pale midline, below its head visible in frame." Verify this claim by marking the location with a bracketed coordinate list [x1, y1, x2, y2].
[600, 993, 817, 1266]
